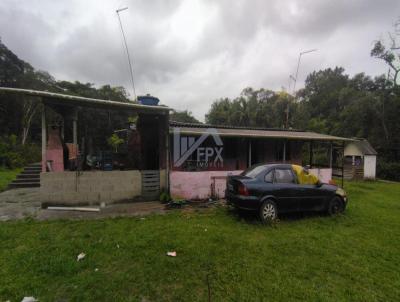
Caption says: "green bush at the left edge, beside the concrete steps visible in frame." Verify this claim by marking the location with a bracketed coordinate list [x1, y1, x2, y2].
[0, 135, 41, 169]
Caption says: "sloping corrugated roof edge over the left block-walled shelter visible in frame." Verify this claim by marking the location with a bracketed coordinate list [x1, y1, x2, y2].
[0, 87, 171, 113]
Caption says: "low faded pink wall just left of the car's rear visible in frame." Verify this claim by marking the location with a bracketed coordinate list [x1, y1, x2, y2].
[169, 170, 242, 200]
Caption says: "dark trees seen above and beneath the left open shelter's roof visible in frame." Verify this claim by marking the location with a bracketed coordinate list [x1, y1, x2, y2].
[0, 40, 129, 144]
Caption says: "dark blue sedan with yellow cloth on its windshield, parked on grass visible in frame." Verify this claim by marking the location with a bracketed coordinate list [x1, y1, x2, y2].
[226, 164, 347, 221]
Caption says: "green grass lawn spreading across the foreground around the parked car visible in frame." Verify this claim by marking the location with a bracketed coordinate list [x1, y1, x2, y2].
[0, 182, 400, 302]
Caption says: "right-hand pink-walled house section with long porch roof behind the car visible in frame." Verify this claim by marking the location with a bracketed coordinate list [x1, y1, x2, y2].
[170, 122, 351, 199]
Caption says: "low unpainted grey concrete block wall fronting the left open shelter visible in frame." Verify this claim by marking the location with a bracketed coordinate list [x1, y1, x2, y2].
[40, 170, 142, 204]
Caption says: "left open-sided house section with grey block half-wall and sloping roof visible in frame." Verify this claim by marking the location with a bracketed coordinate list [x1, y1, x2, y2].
[0, 88, 170, 205]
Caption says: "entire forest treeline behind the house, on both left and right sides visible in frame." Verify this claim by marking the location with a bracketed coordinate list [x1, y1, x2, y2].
[0, 20, 400, 178]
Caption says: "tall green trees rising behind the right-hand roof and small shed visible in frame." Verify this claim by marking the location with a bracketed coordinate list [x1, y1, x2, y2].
[206, 67, 400, 164]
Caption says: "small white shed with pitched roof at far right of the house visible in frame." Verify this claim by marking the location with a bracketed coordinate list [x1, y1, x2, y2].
[344, 139, 378, 179]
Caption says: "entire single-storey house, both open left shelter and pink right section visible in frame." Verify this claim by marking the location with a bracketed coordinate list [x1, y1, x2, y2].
[0, 87, 352, 205]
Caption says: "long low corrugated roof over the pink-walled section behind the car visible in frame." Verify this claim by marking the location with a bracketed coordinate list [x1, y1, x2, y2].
[170, 122, 352, 141]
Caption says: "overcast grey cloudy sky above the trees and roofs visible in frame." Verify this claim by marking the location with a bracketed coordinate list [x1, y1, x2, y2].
[0, 0, 400, 120]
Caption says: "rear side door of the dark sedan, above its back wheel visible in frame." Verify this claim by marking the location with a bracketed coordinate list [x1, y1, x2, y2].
[273, 168, 299, 212]
